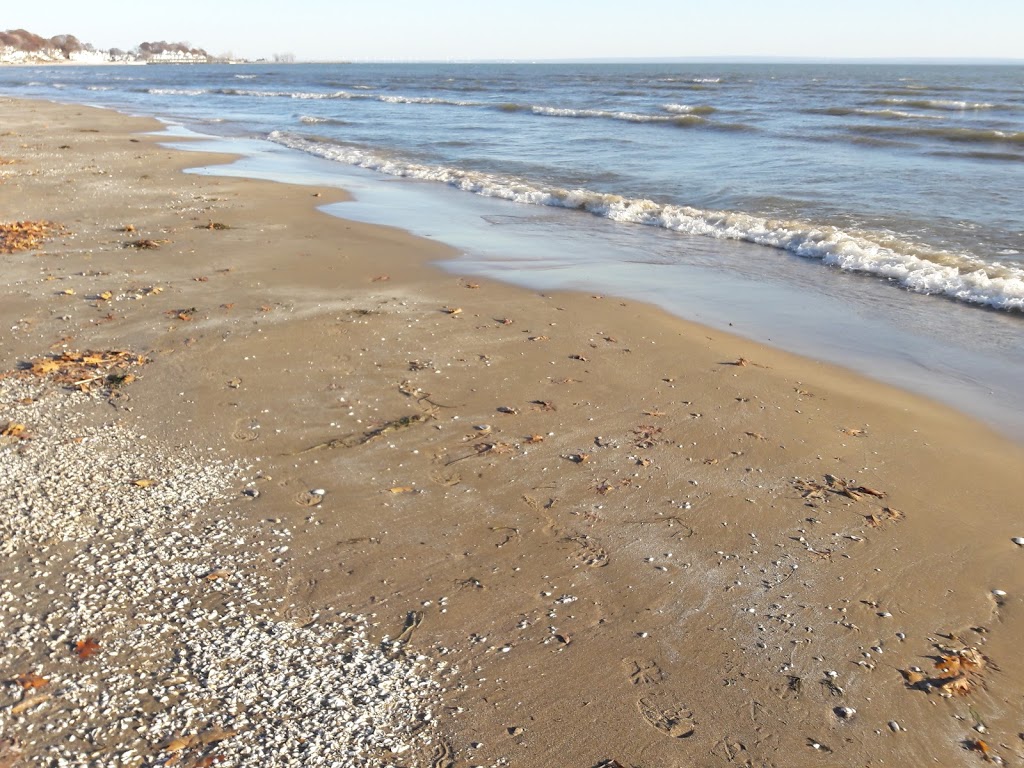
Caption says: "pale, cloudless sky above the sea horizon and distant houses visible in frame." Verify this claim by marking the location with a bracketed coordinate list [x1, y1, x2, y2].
[8, 0, 1024, 60]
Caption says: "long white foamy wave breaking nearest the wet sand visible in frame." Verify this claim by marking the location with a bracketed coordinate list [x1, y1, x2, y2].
[269, 131, 1024, 311]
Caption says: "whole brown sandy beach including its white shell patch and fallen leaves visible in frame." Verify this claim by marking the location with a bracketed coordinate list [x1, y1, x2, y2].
[0, 98, 1024, 768]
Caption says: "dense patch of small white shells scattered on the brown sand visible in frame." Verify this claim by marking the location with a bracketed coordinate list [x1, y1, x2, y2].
[0, 378, 443, 768]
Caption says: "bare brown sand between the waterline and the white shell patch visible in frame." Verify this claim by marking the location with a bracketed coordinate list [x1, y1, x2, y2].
[0, 98, 1024, 766]
